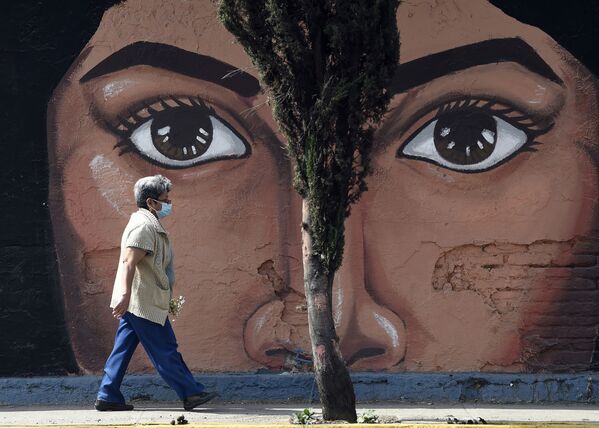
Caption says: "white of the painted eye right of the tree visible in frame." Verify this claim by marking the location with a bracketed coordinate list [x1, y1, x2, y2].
[402, 116, 528, 171]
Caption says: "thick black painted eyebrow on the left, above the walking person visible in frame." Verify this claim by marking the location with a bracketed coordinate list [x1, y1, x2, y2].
[79, 42, 260, 97]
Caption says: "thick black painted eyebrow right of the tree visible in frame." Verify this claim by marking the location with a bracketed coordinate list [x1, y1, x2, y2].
[389, 37, 563, 94]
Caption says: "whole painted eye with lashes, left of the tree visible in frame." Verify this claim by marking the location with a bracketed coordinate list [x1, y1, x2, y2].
[117, 99, 250, 168]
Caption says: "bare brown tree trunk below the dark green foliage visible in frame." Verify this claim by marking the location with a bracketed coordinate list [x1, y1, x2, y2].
[302, 200, 357, 422]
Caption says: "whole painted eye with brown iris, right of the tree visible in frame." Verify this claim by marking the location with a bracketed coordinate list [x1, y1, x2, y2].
[397, 102, 539, 172]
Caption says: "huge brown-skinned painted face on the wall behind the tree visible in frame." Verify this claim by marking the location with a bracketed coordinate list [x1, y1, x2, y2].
[48, 0, 599, 371]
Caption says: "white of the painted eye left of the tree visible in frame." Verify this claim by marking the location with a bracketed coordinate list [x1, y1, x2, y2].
[130, 116, 247, 167]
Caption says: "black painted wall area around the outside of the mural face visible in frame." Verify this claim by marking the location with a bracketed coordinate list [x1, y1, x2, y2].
[0, 0, 599, 376]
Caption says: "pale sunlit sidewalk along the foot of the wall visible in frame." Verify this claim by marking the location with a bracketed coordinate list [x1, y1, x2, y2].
[0, 401, 599, 428]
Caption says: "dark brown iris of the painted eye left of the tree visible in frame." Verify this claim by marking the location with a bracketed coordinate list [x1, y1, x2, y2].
[151, 107, 213, 160]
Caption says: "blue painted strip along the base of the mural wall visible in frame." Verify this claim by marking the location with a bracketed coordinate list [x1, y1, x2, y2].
[0, 372, 599, 405]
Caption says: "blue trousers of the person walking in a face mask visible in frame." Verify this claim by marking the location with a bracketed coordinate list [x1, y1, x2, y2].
[98, 312, 204, 403]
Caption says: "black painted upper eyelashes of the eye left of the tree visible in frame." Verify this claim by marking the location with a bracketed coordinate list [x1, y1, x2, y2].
[108, 95, 216, 156]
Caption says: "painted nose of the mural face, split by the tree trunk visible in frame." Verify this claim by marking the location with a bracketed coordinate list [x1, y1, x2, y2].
[244, 206, 406, 370]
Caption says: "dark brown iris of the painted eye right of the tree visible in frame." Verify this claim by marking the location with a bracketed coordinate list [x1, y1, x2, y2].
[434, 110, 497, 165]
